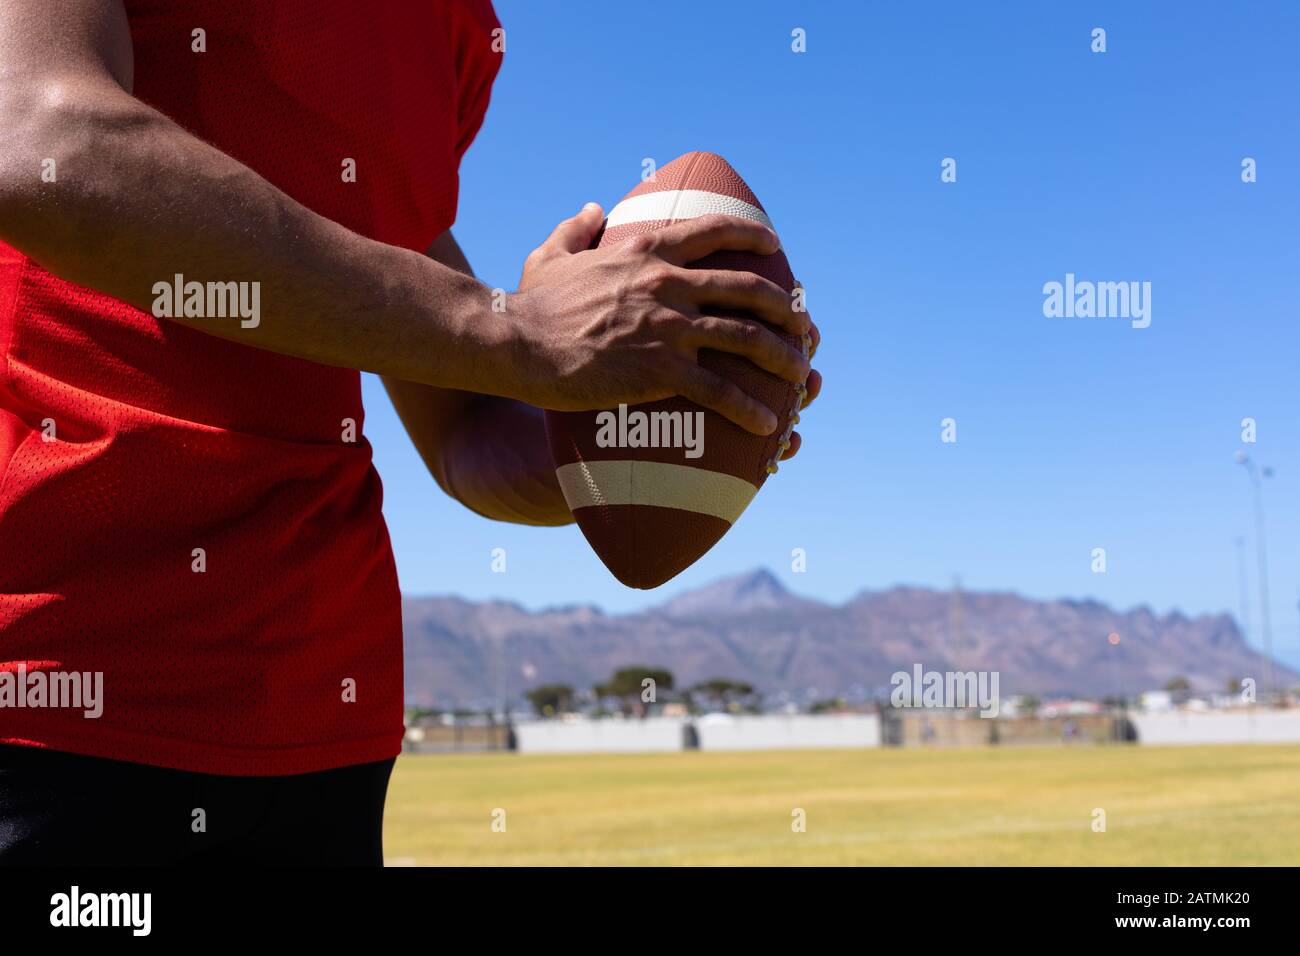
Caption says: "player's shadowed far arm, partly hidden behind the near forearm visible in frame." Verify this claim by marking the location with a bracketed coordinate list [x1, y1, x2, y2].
[384, 232, 573, 525]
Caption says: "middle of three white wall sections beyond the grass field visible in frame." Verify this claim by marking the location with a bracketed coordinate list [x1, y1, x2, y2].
[696, 714, 880, 750]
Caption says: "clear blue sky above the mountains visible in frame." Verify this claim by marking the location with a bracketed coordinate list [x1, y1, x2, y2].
[365, 0, 1300, 663]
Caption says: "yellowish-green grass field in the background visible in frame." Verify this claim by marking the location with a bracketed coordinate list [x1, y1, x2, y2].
[385, 745, 1300, 866]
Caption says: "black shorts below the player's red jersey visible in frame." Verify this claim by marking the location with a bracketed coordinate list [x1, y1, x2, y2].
[0, 745, 394, 866]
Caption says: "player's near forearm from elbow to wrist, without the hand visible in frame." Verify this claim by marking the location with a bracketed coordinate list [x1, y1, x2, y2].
[0, 72, 508, 392]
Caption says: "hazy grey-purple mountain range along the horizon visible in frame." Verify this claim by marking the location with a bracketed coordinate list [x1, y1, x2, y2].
[403, 570, 1296, 706]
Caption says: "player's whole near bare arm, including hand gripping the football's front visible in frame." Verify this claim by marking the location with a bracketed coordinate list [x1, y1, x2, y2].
[0, 0, 810, 434]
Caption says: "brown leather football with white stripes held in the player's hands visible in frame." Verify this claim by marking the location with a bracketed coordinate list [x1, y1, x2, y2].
[546, 152, 809, 588]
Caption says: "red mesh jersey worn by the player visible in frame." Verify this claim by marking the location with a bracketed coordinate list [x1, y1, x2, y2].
[0, 0, 499, 775]
